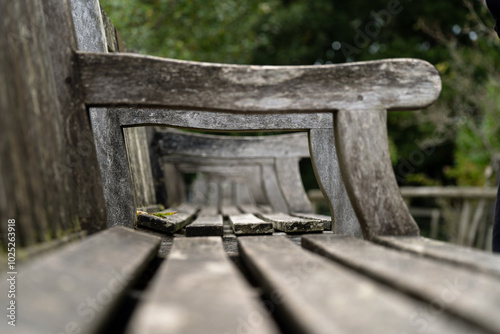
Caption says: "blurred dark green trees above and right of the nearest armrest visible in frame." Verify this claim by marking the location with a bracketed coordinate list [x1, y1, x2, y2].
[101, 0, 500, 186]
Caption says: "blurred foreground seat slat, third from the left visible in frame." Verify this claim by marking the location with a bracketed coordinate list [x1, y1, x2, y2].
[238, 236, 481, 334]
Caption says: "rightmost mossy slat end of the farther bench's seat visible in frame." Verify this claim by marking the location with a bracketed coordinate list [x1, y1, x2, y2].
[260, 213, 324, 233]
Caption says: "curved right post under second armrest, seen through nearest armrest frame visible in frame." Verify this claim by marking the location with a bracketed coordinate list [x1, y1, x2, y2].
[274, 158, 312, 212]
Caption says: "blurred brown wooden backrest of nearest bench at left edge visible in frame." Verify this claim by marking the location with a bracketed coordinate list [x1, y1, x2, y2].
[0, 0, 106, 247]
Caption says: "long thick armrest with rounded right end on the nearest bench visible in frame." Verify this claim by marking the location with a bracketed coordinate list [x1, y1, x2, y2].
[78, 53, 441, 112]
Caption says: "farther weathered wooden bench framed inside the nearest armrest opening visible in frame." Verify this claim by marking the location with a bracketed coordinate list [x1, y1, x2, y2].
[138, 130, 331, 235]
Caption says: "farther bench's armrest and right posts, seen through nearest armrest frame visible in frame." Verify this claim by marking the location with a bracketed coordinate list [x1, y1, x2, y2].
[155, 129, 312, 212]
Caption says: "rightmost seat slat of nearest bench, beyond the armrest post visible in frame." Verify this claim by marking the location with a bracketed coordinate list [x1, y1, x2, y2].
[374, 237, 500, 277]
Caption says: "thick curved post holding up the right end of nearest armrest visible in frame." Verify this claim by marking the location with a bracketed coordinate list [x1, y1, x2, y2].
[335, 110, 419, 239]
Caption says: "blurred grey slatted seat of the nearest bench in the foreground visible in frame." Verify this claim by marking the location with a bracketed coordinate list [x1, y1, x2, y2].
[2, 227, 500, 334]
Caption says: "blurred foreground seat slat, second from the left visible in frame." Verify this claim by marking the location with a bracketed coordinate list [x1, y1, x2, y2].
[127, 237, 277, 334]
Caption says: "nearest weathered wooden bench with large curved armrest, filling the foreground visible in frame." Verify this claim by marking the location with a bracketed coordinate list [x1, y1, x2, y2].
[0, 0, 500, 333]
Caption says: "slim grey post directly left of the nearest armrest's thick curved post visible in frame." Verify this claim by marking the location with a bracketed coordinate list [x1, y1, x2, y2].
[309, 129, 362, 237]
